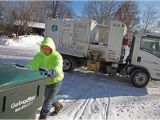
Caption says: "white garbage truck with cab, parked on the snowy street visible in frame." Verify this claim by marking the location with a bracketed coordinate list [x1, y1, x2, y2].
[45, 19, 160, 87]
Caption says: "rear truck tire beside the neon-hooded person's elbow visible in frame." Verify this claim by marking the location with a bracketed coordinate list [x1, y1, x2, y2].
[63, 56, 76, 72]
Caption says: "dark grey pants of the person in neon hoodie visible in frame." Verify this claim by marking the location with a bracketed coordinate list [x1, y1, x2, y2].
[40, 81, 62, 116]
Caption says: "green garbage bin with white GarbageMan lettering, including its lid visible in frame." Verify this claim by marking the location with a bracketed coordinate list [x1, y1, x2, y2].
[0, 63, 47, 119]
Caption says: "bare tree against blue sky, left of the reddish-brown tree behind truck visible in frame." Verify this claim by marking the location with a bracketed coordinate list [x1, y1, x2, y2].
[83, 0, 118, 24]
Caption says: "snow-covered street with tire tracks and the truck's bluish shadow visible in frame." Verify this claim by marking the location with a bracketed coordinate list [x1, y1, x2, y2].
[0, 37, 160, 120]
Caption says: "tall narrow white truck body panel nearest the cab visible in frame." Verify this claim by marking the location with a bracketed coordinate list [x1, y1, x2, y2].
[106, 21, 127, 62]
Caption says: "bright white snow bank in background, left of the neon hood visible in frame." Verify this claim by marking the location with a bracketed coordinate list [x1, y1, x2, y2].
[0, 35, 44, 46]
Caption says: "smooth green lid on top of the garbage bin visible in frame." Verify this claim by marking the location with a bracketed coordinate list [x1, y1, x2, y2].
[0, 63, 47, 91]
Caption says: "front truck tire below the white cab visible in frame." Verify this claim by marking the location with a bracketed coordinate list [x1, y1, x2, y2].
[131, 69, 150, 88]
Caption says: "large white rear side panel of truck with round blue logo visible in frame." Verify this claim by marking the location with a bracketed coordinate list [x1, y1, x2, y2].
[46, 19, 90, 57]
